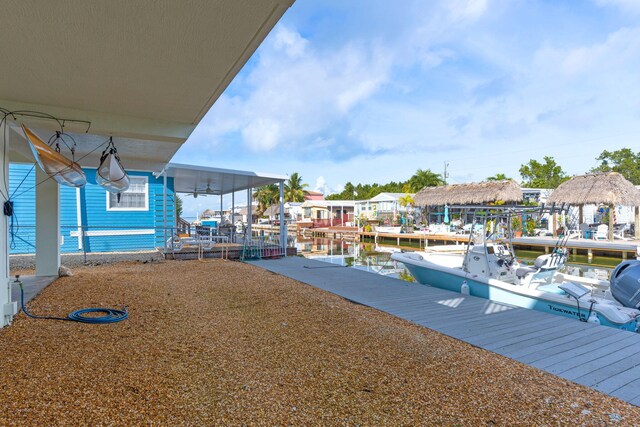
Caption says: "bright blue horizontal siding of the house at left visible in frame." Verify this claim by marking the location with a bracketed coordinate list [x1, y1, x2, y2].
[9, 164, 175, 254]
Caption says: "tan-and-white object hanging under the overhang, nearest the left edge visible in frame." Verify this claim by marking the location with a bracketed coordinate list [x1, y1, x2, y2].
[22, 125, 87, 187]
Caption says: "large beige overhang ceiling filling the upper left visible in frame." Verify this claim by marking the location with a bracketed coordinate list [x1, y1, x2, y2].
[0, 0, 294, 171]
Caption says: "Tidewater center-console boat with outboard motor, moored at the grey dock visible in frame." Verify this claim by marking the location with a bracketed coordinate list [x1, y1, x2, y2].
[391, 207, 640, 331]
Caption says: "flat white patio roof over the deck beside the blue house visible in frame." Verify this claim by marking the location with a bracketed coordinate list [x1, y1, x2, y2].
[165, 163, 287, 195]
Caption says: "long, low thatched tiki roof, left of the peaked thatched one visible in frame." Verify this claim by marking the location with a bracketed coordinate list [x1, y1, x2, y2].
[414, 179, 522, 206]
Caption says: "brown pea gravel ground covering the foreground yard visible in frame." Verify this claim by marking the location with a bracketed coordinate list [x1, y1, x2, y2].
[0, 260, 640, 426]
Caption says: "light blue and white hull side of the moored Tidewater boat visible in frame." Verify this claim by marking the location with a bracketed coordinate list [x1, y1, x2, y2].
[392, 254, 638, 331]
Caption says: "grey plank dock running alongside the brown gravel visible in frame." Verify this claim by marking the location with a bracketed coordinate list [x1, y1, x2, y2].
[251, 257, 640, 406]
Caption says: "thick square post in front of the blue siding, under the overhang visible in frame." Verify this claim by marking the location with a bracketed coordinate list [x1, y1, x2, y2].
[35, 167, 60, 276]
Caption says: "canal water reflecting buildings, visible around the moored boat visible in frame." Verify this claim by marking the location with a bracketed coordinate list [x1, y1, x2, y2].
[296, 236, 622, 281]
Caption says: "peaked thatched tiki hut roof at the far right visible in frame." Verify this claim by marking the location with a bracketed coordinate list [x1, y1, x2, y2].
[547, 172, 640, 206]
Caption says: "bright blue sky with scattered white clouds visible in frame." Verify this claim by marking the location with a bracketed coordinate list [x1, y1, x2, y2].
[173, 0, 640, 215]
